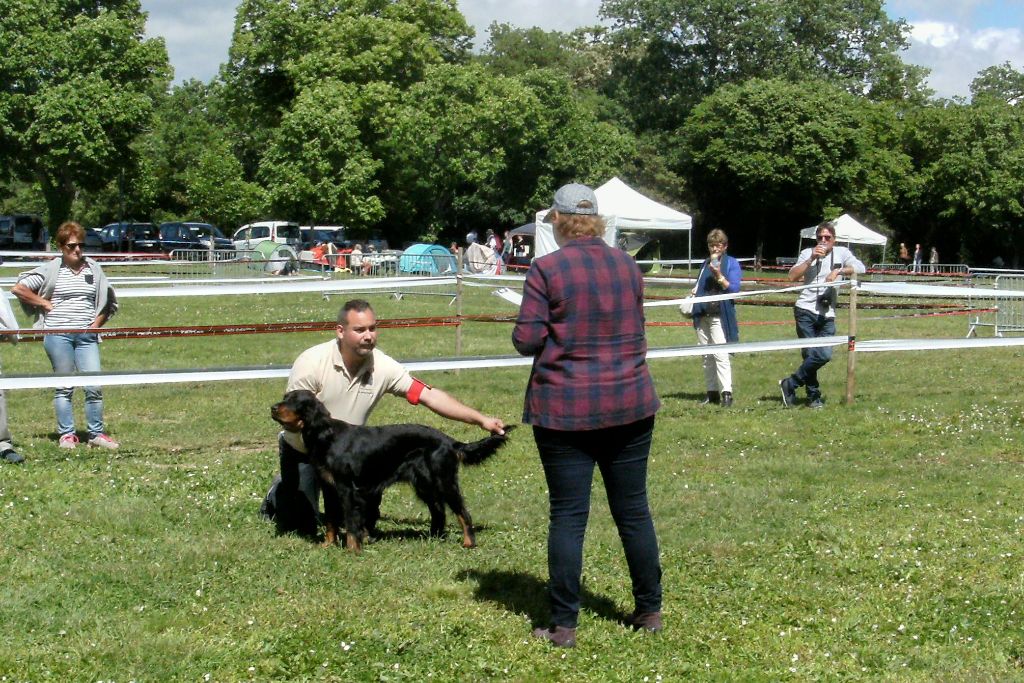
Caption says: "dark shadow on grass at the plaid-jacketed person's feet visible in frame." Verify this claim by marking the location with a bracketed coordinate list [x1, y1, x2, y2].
[459, 569, 627, 627]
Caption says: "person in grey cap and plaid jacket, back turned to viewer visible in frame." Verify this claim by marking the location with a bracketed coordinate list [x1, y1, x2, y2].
[512, 183, 662, 647]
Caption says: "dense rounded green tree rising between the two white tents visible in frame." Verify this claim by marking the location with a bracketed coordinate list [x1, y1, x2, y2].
[679, 80, 909, 259]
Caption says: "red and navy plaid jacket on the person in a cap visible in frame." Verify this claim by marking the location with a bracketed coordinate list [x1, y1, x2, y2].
[512, 238, 660, 431]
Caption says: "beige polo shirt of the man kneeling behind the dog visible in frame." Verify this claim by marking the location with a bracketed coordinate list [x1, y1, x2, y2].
[285, 339, 413, 453]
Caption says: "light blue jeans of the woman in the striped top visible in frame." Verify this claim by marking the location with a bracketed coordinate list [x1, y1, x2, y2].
[43, 332, 106, 438]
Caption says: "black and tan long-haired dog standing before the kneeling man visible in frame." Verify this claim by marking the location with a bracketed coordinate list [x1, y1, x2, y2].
[270, 390, 512, 551]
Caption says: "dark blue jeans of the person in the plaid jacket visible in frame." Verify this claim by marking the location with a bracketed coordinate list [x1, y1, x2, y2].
[534, 416, 662, 628]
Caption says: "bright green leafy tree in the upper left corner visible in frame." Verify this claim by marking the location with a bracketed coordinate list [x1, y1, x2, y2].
[0, 0, 170, 228]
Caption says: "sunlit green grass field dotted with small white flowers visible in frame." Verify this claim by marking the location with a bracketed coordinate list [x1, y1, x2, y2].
[0, 274, 1024, 681]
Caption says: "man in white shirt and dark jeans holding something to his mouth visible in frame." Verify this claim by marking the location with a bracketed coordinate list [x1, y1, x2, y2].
[778, 221, 864, 408]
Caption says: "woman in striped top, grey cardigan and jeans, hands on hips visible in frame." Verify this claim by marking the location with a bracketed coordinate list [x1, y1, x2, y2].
[11, 221, 119, 450]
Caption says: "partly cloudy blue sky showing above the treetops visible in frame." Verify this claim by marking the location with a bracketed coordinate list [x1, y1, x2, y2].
[142, 0, 1024, 97]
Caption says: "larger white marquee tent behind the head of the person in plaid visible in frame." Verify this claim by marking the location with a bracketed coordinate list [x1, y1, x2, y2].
[535, 177, 693, 256]
